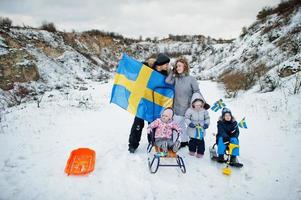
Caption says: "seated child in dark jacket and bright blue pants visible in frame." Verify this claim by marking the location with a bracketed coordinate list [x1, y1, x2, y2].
[216, 108, 242, 167]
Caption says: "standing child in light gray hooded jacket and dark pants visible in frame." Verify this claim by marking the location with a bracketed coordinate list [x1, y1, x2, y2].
[185, 93, 210, 158]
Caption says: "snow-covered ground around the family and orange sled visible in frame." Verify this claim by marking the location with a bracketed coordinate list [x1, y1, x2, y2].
[0, 81, 301, 200]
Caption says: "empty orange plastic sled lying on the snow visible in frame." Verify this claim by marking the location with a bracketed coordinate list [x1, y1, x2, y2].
[65, 148, 95, 176]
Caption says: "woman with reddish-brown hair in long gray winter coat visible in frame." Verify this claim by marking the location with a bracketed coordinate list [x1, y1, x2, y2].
[165, 57, 204, 147]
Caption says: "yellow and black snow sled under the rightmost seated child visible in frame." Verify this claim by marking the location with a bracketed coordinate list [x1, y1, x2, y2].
[209, 142, 243, 176]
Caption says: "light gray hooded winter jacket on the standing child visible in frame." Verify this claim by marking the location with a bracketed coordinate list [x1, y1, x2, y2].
[185, 93, 210, 138]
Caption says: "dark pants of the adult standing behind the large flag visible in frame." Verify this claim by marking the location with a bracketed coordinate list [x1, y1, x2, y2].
[129, 117, 144, 149]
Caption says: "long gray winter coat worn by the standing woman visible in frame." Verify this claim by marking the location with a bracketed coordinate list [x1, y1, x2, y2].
[165, 71, 204, 116]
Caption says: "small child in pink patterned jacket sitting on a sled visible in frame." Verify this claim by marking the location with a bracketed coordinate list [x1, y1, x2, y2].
[147, 108, 181, 153]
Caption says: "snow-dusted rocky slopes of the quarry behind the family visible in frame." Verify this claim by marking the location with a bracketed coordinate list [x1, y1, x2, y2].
[0, 1, 301, 106]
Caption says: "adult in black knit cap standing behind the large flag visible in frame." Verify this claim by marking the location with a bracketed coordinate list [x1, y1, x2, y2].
[128, 53, 170, 153]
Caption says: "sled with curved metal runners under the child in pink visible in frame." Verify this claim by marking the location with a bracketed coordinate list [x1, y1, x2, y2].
[148, 130, 186, 174]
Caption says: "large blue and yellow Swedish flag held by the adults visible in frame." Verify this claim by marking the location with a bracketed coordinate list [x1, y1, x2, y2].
[111, 54, 174, 122]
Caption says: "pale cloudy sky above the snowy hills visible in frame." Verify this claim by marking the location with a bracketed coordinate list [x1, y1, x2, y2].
[0, 0, 280, 39]
